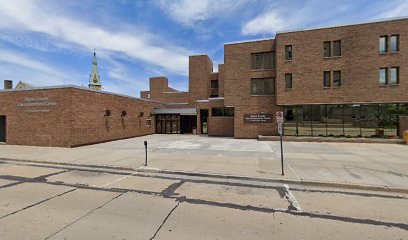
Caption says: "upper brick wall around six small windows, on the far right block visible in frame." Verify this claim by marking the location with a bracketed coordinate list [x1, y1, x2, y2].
[276, 20, 408, 105]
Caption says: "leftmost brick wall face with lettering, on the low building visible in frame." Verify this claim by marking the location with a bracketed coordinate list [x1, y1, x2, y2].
[0, 88, 72, 147]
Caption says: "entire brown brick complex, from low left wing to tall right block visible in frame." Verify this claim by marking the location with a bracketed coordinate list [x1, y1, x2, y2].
[0, 18, 408, 147]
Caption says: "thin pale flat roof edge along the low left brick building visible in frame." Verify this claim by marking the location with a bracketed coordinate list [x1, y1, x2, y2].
[0, 85, 168, 105]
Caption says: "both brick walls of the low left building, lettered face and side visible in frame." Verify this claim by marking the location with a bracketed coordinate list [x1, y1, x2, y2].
[0, 88, 165, 147]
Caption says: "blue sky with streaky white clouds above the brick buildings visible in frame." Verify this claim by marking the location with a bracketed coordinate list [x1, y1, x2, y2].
[0, 0, 408, 97]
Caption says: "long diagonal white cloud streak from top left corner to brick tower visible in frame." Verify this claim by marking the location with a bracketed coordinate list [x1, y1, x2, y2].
[0, 0, 190, 75]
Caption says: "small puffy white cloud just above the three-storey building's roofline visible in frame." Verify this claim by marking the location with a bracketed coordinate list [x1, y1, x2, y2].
[242, 11, 288, 35]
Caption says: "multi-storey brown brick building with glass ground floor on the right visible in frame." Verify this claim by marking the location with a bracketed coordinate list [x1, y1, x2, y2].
[141, 18, 408, 138]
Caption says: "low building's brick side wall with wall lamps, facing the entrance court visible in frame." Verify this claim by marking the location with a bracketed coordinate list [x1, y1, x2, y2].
[71, 89, 163, 146]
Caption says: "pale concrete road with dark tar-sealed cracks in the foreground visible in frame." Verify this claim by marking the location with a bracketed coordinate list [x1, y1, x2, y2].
[0, 160, 408, 240]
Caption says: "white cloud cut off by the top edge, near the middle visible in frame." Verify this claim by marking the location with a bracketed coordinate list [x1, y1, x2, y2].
[159, 0, 246, 27]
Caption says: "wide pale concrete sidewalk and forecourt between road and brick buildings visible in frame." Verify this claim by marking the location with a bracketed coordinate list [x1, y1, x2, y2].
[0, 135, 408, 189]
